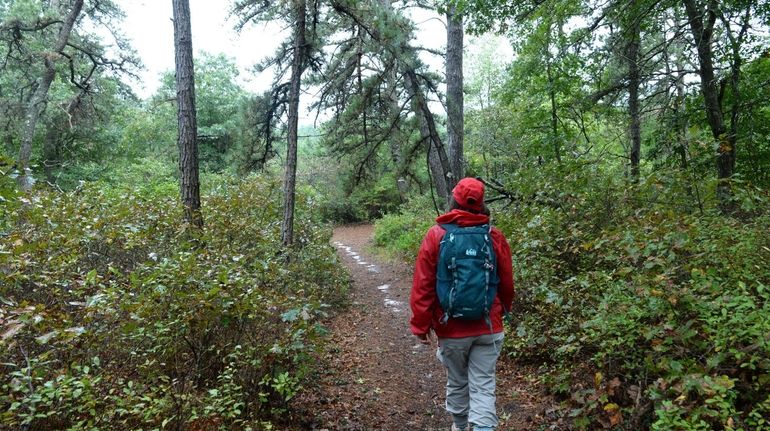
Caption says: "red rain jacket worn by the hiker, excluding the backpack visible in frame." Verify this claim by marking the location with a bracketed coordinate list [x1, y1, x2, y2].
[409, 209, 514, 338]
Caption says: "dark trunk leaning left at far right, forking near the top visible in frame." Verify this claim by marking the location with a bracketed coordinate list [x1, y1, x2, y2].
[683, 0, 736, 202]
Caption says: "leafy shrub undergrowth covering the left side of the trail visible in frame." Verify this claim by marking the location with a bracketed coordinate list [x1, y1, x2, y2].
[0, 177, 348, 430]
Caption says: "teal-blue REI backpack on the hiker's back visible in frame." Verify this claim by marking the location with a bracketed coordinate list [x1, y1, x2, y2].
[436, 224, 500, 326]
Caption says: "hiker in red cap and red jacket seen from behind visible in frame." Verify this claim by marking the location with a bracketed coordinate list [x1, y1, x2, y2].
[409, 178, 514, 431]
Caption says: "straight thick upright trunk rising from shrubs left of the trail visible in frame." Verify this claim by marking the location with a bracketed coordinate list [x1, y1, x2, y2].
[172, 0, 203, 228]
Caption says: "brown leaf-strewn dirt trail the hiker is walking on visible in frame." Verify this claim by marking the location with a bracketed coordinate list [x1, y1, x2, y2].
[293, 225, 555, 431]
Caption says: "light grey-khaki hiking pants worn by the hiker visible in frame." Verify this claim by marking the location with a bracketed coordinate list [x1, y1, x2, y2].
[436, 332, 504, 431]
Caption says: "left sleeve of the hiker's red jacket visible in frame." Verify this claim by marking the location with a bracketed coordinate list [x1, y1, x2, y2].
[409, 226, 440, 335]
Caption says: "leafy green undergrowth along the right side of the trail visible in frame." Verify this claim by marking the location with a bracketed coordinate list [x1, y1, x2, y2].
[377, 166, 770, 431]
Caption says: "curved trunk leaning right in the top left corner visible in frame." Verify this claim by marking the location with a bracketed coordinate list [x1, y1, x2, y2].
[18, 0, 83, 191]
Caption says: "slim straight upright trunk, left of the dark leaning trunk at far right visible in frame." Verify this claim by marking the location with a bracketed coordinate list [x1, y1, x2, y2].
[626, 10, 642, 183]
